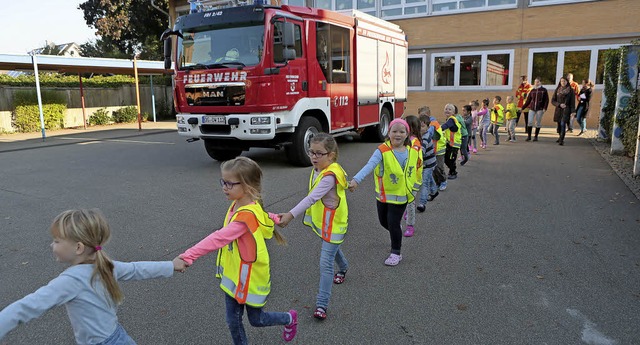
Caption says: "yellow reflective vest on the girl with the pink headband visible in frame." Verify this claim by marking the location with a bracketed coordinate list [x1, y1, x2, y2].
[374, 141, 418, 205]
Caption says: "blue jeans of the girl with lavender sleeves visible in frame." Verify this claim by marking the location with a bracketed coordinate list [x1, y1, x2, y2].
[316, 241, 349, 310]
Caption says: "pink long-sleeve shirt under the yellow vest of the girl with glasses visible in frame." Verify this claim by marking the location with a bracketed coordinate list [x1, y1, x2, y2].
[179, 204, 280, 265]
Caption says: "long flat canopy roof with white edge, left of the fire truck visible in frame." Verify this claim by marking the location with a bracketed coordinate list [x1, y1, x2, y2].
[0, 54, 173, 75]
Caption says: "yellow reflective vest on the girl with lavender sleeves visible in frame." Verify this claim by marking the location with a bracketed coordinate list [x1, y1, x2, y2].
[304, 163, 349, 244]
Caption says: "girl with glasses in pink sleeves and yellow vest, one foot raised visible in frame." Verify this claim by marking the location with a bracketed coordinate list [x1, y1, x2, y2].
[178, 157, 298, 344]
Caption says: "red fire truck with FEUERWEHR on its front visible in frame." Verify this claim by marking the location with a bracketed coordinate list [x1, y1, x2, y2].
[162, 4, 408, 166]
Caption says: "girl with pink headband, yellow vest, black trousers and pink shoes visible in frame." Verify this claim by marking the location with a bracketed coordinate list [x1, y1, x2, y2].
[349, 119, 418, 266]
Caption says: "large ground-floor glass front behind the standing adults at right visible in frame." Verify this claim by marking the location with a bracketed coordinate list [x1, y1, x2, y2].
[529, 45, 620, 87]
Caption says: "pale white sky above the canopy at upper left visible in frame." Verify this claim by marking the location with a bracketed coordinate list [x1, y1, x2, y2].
[0, 0, 96, 54]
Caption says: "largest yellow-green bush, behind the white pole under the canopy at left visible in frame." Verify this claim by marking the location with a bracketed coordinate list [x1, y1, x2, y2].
[13, 90, 67, 132]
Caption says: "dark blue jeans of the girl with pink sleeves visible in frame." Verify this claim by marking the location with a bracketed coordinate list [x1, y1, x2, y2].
[224, 293, 291, 345]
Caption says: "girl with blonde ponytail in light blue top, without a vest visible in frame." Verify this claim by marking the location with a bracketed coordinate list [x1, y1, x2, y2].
[0, 209, 186, 345]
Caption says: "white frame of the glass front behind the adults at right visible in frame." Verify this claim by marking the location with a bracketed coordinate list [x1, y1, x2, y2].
[527, 44, 624, 89]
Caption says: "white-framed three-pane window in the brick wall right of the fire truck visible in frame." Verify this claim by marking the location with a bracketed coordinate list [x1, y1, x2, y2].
[431, 50, 513, 90]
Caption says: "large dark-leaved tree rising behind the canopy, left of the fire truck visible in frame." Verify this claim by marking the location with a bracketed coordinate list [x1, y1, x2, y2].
[78, 0, 169, 60]
